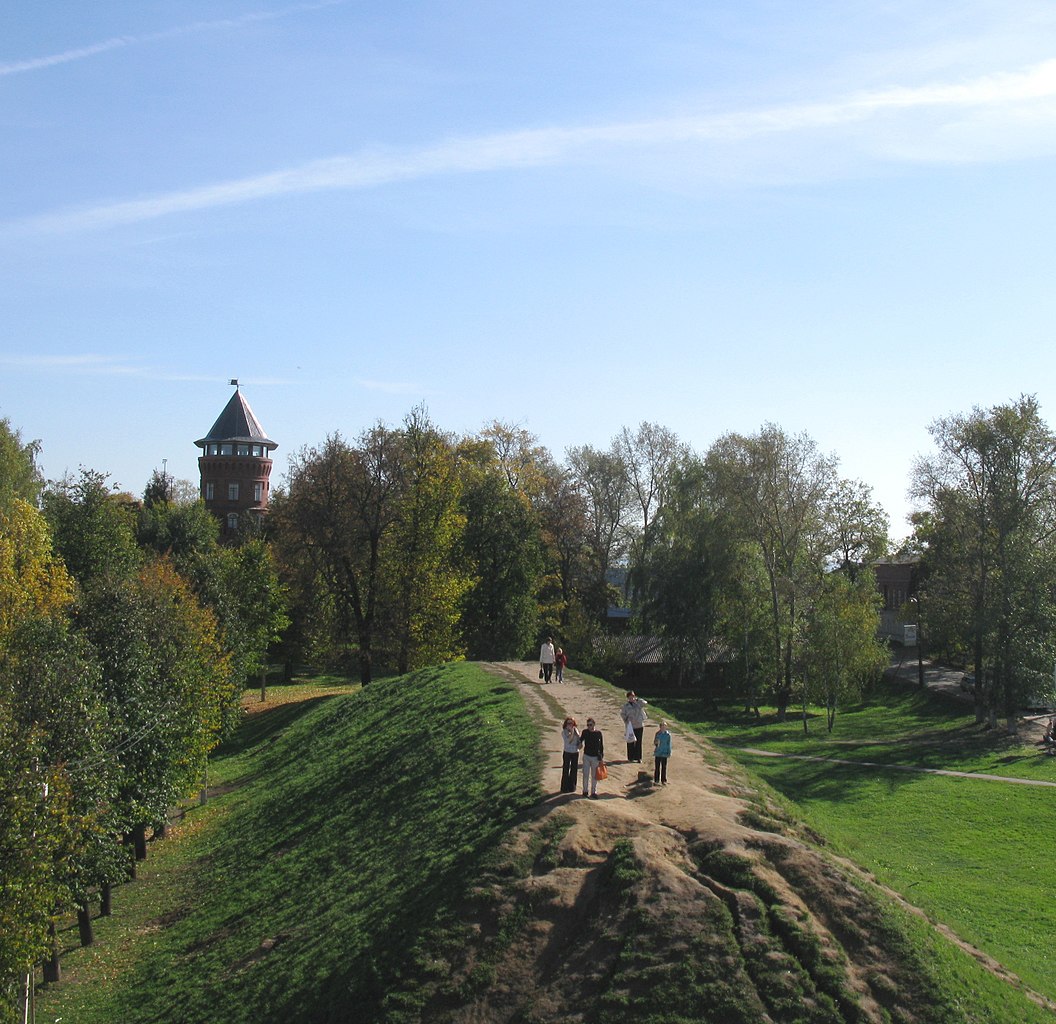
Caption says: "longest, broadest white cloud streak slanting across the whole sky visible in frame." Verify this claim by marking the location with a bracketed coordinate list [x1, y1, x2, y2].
[6, 59, 1056, 232]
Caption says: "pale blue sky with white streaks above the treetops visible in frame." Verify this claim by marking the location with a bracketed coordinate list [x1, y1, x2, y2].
[0, 0, 1056, 536]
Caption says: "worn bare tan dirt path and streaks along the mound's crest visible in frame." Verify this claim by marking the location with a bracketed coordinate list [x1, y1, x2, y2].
[468, 662, 1056, 1022]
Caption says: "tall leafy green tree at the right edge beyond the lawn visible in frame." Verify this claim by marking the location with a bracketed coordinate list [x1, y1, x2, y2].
[913, 396, 1056, 732]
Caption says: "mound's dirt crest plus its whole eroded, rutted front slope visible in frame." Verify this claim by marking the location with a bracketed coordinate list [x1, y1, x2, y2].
[416, 663, 1051, 1024]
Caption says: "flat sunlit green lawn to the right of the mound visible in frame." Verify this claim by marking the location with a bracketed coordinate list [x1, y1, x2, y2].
[654, 683, 1056, 1000]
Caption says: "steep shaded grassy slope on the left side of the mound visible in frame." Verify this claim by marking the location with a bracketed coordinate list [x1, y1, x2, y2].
[38, 664, 540, 1024]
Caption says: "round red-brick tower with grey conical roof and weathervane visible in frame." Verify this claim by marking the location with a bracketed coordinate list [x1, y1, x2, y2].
[194, 380, 279, 543]
